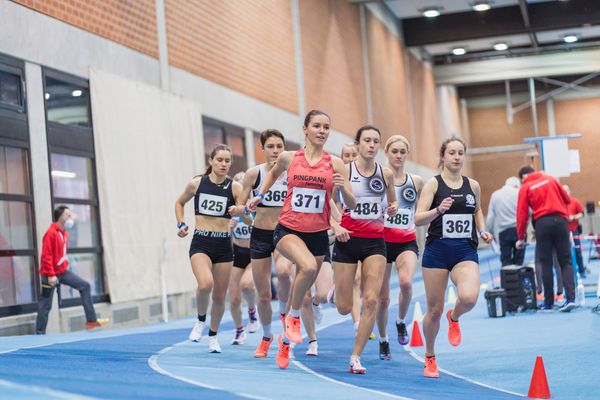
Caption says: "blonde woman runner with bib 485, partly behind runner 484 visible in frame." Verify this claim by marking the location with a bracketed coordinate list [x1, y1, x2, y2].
[377, 135, 423, 360]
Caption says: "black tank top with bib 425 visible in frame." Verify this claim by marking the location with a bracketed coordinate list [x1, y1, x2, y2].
[194, 175, 235, 218]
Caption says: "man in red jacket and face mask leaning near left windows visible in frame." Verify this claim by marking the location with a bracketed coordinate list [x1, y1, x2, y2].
[35, 206, 108, 335]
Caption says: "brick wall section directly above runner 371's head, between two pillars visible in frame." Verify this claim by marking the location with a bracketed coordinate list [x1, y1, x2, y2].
[300, 0, 367, 136]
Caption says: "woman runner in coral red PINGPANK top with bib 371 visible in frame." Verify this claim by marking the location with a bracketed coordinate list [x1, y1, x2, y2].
[248, 110, 356, 368]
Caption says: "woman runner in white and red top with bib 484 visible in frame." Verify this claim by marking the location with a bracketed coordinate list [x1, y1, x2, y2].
[332, 125, 397, 374]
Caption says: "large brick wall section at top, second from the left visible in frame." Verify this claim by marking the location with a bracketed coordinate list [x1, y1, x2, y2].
[165, 0, 298, 112]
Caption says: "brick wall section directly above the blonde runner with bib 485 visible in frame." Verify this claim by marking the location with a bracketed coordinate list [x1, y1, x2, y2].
[366, 12, 410, 143]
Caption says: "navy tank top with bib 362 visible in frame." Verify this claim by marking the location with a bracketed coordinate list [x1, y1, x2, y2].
[427, 175, 478, 247]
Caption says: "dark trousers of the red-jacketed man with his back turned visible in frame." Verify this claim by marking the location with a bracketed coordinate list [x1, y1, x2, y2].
[535, 215, 575, 306]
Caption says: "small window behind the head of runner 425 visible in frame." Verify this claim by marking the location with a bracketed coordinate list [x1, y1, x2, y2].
[202, 117, 248, 176]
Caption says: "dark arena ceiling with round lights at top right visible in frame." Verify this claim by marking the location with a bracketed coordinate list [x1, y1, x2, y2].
[349, 0, 600, 65]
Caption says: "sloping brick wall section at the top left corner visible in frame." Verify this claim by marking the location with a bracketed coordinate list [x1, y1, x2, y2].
[13, 0, 158, 57]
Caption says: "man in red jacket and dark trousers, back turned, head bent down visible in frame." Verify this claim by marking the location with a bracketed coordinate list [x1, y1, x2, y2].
[516, 166, 575, 312]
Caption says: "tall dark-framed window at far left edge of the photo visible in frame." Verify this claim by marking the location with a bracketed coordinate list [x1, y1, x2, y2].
[0, 55, 39, 316]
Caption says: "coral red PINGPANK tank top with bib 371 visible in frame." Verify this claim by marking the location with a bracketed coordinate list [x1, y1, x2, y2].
[279, 150, 333, 232]
